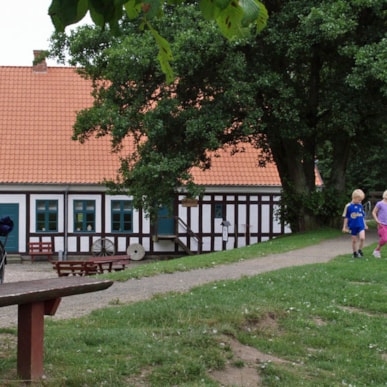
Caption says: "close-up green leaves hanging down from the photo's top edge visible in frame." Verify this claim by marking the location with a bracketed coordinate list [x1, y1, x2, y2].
[48, 0, 268, 82]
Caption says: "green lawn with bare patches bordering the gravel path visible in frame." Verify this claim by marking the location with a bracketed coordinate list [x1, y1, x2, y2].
[0, 226, 387, 386]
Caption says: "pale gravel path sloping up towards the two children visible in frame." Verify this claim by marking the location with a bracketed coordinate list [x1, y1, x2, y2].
[0, 231, 377, 327]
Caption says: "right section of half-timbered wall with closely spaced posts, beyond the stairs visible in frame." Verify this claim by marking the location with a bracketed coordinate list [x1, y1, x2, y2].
[178, 193, 290, 252]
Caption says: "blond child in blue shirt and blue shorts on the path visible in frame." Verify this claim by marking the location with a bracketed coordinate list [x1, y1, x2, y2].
[343, 189, 368, 258]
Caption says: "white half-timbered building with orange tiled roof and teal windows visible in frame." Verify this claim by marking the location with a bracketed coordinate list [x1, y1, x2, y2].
[0, 57, 289, 255]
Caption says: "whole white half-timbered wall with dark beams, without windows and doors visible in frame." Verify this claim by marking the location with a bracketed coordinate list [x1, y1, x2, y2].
[0, 187, 290, 256]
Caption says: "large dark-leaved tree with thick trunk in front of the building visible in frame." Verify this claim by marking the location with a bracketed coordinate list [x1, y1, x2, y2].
[52, 0, 387, 231]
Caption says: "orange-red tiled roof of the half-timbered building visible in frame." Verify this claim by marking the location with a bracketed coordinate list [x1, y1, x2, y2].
[0, 66, 280, 186]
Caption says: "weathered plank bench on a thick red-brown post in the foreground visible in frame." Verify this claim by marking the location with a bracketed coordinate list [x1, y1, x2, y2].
[0, 277, 113, 381]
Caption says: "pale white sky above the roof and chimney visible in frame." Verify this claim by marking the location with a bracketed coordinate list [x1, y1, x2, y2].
[0, 0, 89, 66]
